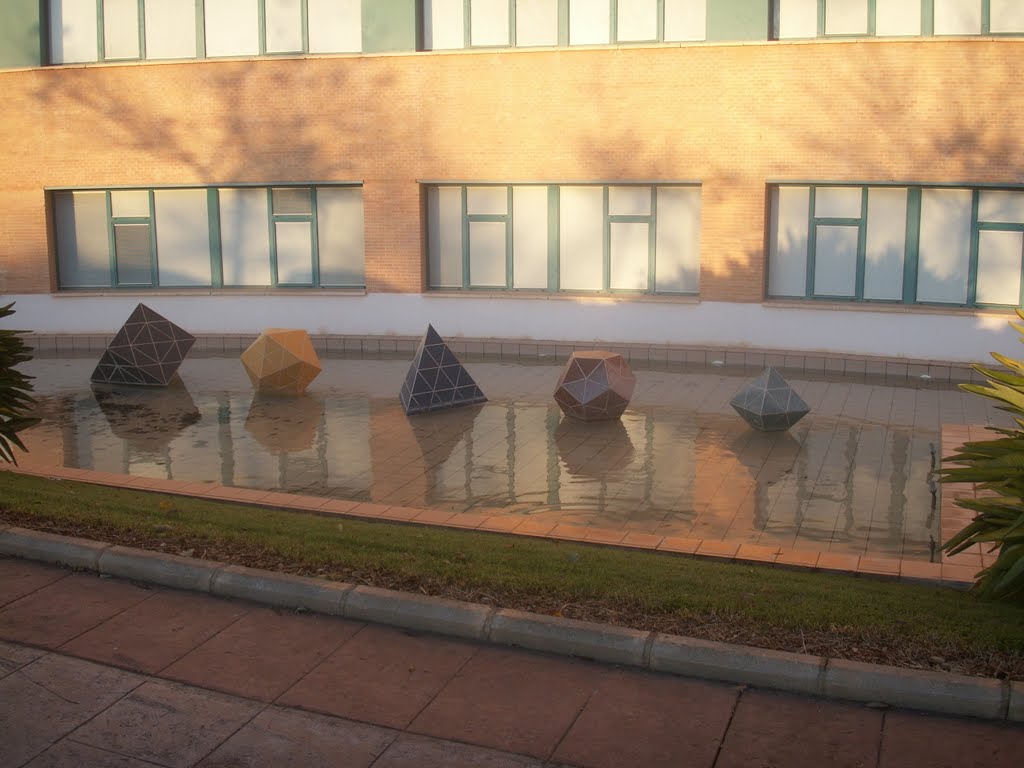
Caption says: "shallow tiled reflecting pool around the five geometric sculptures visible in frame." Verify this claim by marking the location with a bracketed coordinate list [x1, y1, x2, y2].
[16, 354, 1007, 559]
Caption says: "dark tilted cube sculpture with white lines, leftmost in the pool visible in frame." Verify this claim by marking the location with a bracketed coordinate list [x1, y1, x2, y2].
[91, 304, 196, 386]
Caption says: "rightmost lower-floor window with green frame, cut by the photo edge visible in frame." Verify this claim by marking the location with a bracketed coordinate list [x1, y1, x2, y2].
[768, 184, 1024, 306]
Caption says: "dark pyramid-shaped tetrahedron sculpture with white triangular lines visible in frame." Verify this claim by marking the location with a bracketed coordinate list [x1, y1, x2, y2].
[398, 326, 487, 415]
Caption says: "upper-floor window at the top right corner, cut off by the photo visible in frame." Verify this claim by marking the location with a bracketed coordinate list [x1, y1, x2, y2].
[774, 0, 1024, 40]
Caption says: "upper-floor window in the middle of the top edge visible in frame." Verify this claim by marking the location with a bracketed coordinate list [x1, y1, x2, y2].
[424, 0, 707, 50]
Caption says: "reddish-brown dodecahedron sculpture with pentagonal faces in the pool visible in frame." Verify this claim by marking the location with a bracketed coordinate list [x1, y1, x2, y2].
[555, 351, 636, 421]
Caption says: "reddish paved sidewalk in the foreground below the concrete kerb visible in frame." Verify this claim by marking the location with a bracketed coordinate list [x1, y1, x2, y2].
[0, 558, 1024, 768]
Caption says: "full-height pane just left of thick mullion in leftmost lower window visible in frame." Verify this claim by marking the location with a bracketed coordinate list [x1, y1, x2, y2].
[154, 189, 211, 286]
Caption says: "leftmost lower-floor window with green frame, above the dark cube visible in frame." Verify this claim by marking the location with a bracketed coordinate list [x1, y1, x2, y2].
[52, 186, 364, 289]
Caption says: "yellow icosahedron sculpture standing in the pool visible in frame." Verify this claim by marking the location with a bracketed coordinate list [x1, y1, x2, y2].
[242, 328, 322, 395]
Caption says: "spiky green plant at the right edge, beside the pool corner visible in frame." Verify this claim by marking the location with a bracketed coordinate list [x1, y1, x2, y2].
[939, 309, 1024, 600]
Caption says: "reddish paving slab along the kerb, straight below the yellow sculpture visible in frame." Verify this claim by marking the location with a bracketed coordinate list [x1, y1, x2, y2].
[162, 608, 362, 701]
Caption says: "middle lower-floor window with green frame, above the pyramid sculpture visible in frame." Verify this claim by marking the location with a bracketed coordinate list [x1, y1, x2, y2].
[426, 184, 700, 294]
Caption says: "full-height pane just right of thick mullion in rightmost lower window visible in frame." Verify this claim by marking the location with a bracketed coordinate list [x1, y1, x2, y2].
[918, 189, 972, 304]
